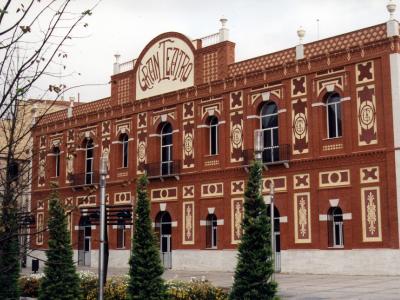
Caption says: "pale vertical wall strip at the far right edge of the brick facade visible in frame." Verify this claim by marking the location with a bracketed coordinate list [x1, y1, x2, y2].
[389, 53, 400, 244]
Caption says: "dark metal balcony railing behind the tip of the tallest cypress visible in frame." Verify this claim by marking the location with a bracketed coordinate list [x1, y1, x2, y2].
[243, 144, 290, 166]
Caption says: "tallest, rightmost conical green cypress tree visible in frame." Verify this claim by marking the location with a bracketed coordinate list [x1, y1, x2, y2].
[230, 162, 277, 300]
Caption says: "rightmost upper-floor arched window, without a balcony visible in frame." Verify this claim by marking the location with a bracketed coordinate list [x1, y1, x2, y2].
[326, 93, 342, 138]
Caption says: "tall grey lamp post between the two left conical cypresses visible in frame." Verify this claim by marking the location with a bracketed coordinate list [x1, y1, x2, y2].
[99, 156, 108, 300]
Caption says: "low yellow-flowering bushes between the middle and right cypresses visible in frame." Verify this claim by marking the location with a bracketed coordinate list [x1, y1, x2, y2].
[167, 280, 228, 300]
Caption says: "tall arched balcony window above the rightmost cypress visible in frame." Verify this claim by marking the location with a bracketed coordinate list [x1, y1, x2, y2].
[260, 101, 279, 163]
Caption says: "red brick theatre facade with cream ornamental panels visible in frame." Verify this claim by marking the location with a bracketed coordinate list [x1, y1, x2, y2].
[32, 16, 400, 274]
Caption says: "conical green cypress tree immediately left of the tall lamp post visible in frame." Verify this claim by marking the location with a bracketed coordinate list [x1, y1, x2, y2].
[39, 190, 80, 300]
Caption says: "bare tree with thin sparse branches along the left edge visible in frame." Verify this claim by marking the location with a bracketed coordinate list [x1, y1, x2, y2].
[0, 0, 100, 299]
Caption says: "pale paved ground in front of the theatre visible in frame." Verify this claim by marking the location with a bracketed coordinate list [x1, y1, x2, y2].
[24, 268, 400, 300]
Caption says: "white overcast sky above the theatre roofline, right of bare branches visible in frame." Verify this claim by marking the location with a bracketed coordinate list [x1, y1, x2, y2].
[42, 0, 392, 101]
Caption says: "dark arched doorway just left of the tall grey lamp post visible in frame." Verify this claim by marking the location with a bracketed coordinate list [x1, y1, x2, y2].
[78, 216, 92, 266]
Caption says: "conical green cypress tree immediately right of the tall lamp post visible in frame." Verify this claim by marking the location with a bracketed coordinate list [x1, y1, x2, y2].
[128, 175, 166, 300]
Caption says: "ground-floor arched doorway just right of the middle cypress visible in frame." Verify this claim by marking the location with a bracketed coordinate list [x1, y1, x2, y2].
[156, 211, 172, 269]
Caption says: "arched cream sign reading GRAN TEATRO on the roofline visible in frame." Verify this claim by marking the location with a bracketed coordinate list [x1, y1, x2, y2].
[136, 37, 194, 100]
